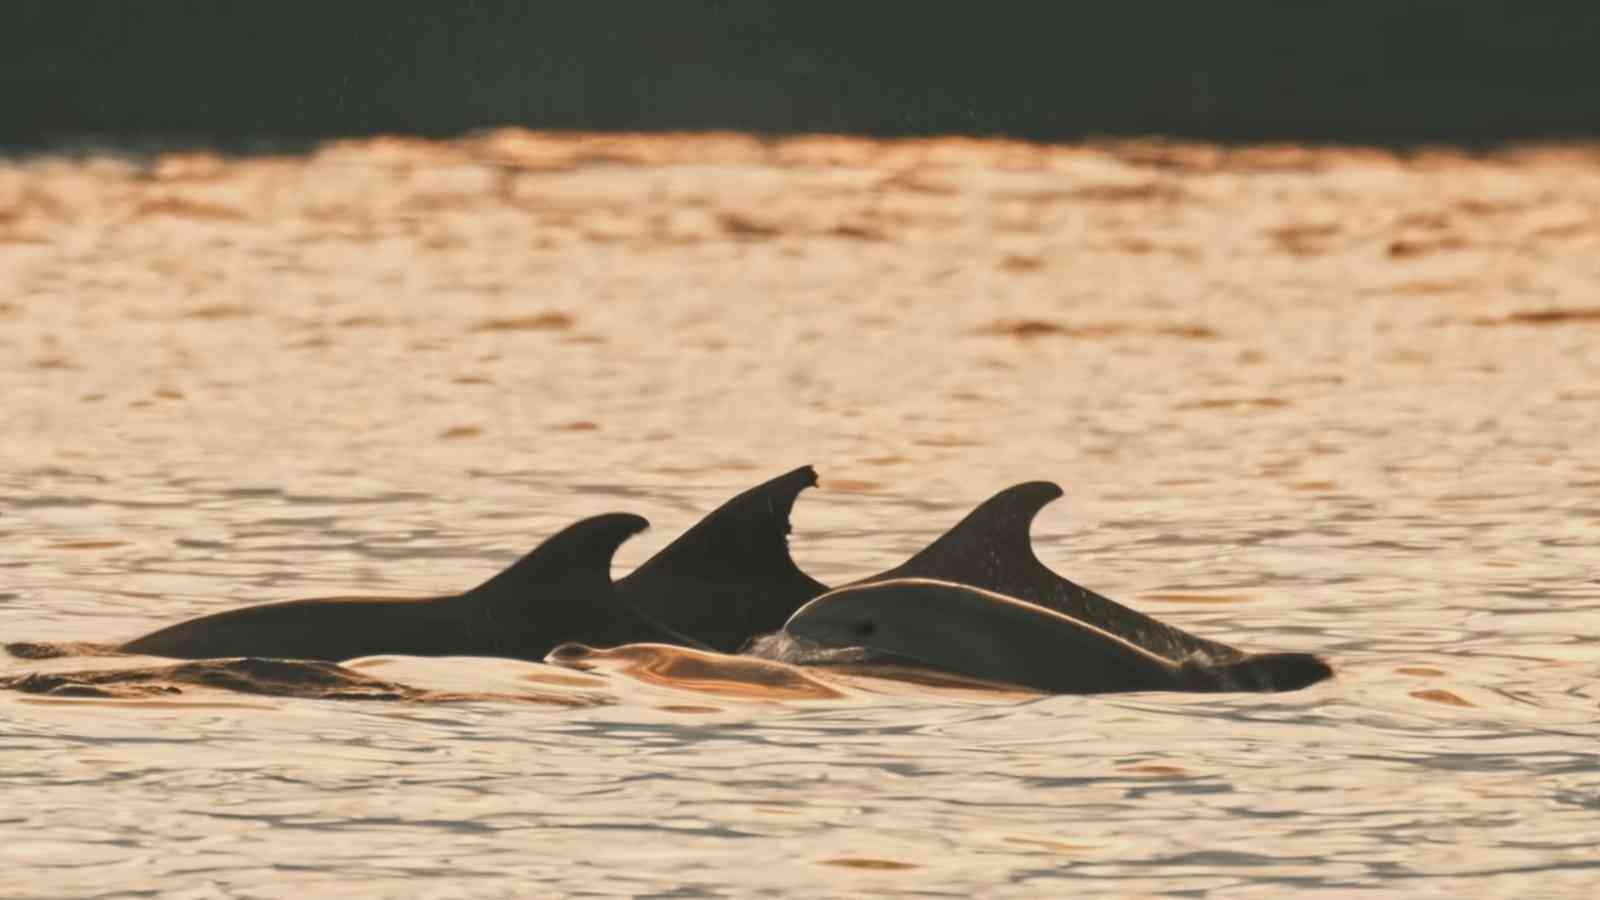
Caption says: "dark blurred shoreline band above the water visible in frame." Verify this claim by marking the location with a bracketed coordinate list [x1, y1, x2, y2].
[12, 0, 1600, 152]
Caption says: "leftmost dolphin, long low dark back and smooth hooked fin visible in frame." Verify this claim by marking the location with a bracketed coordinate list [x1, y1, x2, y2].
[120, 512, 669, 661]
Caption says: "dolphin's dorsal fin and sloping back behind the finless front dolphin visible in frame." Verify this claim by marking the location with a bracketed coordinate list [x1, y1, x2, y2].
[856, 482, 1242, 661]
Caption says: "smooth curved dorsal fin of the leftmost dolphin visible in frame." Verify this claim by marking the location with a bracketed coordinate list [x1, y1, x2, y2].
[467, 512, 650, 602]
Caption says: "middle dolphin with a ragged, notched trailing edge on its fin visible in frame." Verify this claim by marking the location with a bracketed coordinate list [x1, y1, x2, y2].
[616, 466, 827, 652]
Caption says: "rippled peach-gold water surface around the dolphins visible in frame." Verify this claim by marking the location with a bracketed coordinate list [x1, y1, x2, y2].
[0, 133, 1600, 897]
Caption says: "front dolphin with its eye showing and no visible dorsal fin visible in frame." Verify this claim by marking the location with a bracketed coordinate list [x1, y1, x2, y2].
[784, 578, 1333, 693]
